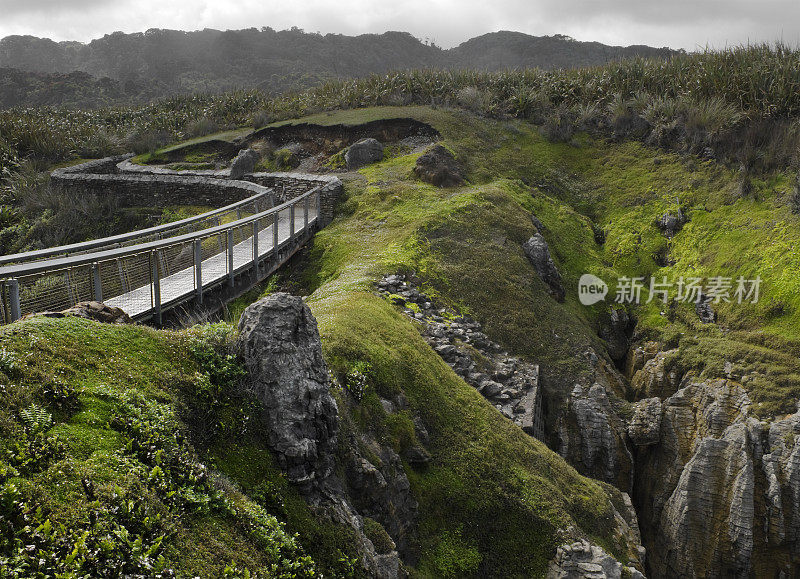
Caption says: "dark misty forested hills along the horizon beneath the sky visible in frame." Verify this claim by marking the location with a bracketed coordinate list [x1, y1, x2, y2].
[0, 28, 673, 108]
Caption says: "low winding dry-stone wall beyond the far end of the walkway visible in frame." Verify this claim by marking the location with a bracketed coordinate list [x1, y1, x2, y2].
[50, 155, 342, 226]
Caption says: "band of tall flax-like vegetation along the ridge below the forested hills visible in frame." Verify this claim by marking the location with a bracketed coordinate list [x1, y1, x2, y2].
[0, 45, 800, 168]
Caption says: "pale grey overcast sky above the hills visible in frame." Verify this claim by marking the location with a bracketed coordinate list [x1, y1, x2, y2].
[0, 0, 800, 50]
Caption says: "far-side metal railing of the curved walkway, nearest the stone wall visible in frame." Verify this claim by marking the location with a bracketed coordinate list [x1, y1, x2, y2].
[0, 189, 275, 266]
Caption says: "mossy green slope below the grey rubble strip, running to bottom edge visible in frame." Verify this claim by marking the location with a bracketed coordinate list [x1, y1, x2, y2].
[309, 294, 628, 576]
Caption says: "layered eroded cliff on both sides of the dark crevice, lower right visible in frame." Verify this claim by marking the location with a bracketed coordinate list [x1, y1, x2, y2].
[536, 330, 800, 577]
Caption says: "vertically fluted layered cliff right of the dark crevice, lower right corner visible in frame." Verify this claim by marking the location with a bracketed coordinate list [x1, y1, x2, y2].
[629, 355, 800, 577]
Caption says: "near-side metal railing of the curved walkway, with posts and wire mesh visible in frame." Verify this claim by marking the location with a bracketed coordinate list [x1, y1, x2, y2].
[0, 187, 321, 323]
